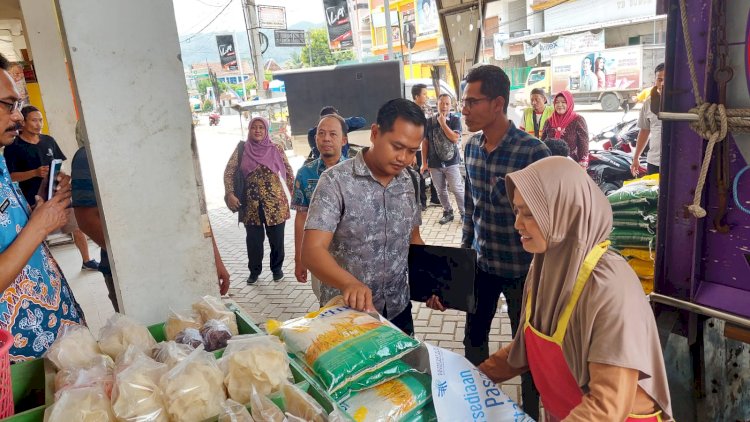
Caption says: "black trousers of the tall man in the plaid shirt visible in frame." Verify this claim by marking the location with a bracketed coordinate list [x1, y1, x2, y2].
[464, 270, 539, 420]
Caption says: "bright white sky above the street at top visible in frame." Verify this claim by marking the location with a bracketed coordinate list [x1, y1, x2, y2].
[172, 0, 325, 36]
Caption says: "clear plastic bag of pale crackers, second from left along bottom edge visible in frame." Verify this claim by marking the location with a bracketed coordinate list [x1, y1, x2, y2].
[112, 346, 169, 422]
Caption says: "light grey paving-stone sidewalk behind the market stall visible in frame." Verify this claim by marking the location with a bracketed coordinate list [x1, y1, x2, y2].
[209, 198, 520, 402]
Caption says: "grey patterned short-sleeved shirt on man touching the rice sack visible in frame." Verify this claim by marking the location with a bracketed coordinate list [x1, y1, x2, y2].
[305, 149, 422, 318]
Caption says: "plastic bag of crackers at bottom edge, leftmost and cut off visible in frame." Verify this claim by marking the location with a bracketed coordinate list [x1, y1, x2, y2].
[44, 385, 115, 422]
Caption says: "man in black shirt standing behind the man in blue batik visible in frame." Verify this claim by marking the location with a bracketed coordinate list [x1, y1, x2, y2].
[4, 106, 99, 271]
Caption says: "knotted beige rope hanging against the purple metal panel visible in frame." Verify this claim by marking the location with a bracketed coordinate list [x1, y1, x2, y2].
[679, 0, 750, 218]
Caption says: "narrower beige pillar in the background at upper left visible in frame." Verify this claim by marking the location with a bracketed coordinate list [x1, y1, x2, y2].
[20, 0, 78, 162]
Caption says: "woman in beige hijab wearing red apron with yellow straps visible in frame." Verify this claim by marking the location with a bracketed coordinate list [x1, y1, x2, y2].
[479, 157, 672, 422]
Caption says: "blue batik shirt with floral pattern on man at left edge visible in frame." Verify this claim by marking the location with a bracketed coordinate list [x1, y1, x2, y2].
[0, 158, 85, 362]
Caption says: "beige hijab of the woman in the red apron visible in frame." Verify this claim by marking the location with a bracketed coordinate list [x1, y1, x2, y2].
[506, 157, 671, 415]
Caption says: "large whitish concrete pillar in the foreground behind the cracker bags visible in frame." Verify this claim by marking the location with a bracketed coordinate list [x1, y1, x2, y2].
[56, 0, 218, 323]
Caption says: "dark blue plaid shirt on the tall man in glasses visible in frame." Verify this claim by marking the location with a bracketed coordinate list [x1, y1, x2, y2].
[461, 122, 550, 278]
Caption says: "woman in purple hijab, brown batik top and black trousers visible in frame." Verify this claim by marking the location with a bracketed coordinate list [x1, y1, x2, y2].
[224, 117, 294, 284]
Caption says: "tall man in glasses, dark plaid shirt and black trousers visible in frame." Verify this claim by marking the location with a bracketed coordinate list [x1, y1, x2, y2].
[427, 65, 550, 420]
